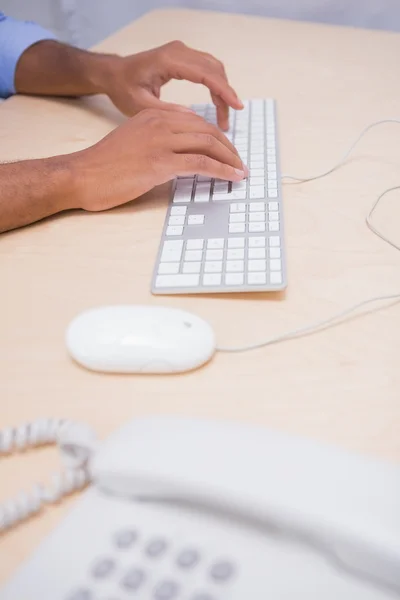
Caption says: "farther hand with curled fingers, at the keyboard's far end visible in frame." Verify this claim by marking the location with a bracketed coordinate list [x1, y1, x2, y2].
[104, 41, 243, 130]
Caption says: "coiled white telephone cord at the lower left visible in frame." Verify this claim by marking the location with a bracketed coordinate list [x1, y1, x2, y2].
[0, 419, 96, 535]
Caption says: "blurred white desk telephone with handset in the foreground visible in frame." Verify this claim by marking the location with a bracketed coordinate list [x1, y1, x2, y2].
[0, 416, 400, 600]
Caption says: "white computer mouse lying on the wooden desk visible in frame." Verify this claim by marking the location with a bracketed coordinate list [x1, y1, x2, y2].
[66, 305, 216, 373]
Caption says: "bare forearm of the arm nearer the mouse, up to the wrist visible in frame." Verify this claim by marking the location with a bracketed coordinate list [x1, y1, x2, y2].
[0, 156, 78, 233]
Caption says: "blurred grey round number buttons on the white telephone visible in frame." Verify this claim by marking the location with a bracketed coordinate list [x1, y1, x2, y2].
[65, 528, 236, 600]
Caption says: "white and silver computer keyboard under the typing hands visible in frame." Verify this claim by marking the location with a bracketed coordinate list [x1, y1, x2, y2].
[152, 99, 287, 294]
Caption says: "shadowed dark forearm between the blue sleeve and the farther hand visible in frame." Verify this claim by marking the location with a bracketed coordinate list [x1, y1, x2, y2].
[15, 40, 120, 96]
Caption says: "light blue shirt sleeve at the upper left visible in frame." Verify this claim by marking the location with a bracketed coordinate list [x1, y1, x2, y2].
[0, 12, 56, 98]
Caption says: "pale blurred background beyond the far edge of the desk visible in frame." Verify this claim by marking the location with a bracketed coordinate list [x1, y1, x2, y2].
[0, 0, 400, 47]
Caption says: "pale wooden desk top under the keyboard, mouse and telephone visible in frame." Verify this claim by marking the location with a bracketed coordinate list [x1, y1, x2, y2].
[0, 10, 400, 581]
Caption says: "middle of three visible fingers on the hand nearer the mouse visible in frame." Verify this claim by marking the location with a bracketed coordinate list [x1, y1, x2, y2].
[172, 133, 244, 171]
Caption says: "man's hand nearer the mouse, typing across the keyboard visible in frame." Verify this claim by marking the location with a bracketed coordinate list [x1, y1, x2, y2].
[70, 109, 248, 211]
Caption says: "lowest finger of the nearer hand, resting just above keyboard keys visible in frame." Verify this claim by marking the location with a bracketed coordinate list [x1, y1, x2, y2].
[172, 154, 245, 181]
